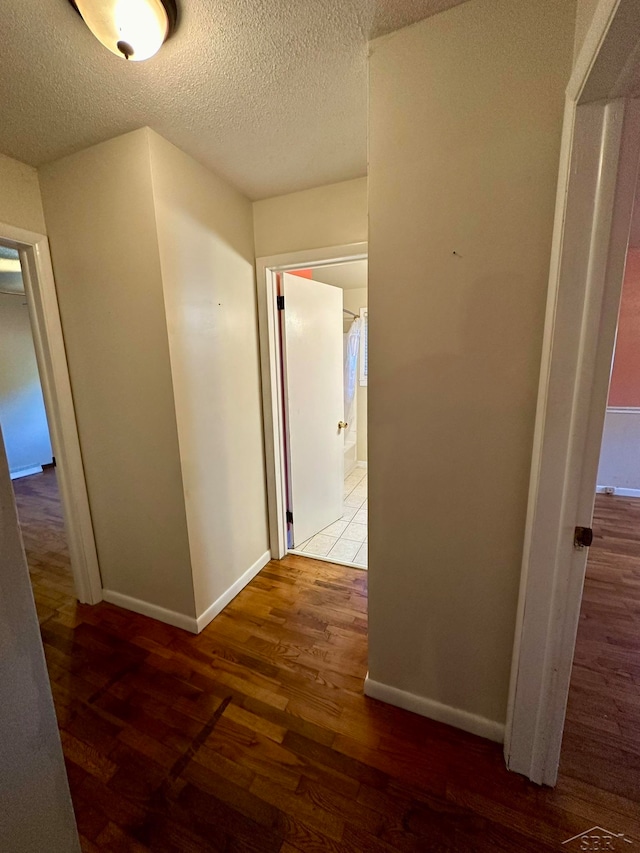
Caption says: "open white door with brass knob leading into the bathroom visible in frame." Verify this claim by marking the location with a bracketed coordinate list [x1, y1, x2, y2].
[282, 273, 344, 548]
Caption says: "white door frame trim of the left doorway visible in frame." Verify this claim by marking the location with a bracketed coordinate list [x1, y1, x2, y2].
[0, 223, 102, 604]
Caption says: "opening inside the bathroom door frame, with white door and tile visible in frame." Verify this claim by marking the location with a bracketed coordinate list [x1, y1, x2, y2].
[277, 260, 368, 569]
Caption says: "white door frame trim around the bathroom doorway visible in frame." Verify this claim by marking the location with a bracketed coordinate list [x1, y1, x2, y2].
[256, 243, 368, 560]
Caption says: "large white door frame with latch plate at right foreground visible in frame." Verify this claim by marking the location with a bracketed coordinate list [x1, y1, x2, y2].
[505, 0, 640, 785]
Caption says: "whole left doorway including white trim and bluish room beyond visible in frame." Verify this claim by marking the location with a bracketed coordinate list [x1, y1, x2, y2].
[0, 223, 102, 611]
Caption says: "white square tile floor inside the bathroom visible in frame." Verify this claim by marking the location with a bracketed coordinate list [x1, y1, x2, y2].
[296, 468, 369, 569]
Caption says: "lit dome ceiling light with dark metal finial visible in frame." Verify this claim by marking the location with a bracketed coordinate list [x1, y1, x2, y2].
[69, 0, 178, 61]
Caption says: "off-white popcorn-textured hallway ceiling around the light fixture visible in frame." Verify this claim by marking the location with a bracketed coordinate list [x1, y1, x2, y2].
[0, 0, 463, 199]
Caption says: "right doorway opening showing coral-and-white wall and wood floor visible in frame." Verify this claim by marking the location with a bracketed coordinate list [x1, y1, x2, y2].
[560, 185, 640, 800]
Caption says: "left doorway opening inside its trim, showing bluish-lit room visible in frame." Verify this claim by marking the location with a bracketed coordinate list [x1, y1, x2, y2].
[0, 243, 76, 622]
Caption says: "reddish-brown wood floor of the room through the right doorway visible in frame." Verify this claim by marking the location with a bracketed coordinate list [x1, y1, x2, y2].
[560, 495, 640, 801]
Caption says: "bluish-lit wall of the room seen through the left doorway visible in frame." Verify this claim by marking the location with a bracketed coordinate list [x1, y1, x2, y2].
[0, 293, 53, 474]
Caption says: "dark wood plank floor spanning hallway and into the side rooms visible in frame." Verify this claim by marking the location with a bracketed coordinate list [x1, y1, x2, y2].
[10, 472, 640, 853]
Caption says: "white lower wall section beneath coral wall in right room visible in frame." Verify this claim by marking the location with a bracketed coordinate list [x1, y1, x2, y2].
[598, 408, 640, 497]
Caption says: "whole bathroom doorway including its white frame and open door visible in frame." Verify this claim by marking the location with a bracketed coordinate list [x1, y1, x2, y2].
[258, 244, 369, 569]
